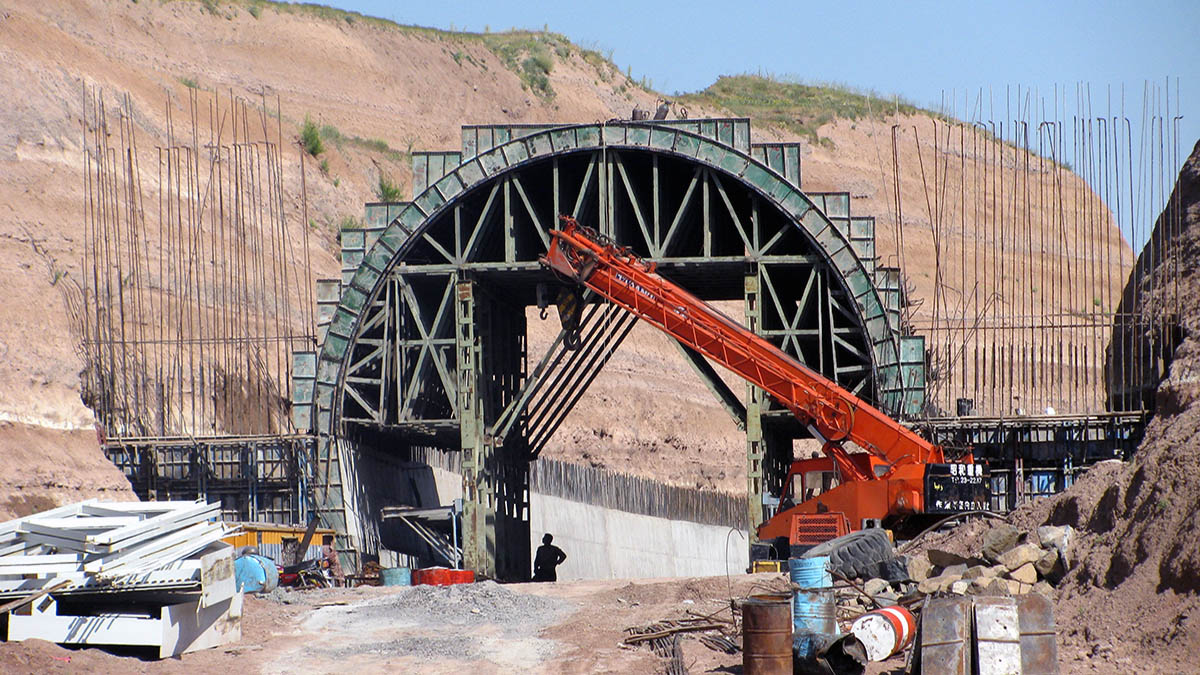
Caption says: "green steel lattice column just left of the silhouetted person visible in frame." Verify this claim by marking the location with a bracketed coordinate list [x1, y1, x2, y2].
[455, 279, 496, 578]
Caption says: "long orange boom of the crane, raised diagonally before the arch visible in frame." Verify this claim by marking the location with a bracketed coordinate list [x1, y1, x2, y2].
[542, 216, 944, 480]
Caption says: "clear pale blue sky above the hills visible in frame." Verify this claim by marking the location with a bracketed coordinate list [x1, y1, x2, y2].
[325, 0, 1200, 243]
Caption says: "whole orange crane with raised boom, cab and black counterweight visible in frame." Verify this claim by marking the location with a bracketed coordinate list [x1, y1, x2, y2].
[541, 216, 986, 544]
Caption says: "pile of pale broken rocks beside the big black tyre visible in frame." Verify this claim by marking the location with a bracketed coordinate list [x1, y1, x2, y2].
[908, 524, 1075, 597]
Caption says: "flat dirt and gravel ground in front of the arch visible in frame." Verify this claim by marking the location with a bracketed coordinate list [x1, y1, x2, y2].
[0, 574, 904, 675]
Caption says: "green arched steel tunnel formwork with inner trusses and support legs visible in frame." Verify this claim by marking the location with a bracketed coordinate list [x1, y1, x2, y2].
[298, 120, 924, 579]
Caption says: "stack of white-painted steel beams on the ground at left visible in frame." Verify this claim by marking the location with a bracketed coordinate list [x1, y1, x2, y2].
[0, 500, 242, 658]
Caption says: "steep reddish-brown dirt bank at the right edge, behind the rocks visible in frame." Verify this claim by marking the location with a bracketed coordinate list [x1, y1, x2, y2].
[902, 143, 1200, 673]
